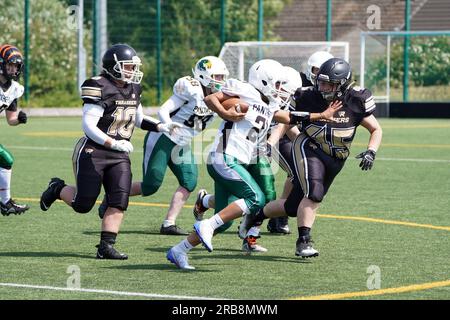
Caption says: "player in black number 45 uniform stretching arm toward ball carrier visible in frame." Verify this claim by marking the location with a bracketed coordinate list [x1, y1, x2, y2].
[243, 58, 382, 258]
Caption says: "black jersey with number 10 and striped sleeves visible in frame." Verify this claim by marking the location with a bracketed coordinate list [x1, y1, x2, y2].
[81, 75, 142, 140]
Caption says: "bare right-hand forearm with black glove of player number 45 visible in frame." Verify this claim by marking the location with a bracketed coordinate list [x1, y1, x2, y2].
[356, 114, 383, 170]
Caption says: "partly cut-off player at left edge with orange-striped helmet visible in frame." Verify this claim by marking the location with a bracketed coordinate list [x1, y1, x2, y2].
[0, 44, 29, 216]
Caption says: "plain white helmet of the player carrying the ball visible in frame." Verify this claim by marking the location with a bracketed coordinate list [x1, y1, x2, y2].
[248, 59, 286, 104]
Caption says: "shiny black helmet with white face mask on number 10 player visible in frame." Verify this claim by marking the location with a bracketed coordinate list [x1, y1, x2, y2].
[102, 43, 144, 84]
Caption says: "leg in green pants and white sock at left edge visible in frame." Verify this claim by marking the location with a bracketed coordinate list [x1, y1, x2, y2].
[0, 144, 30, 216]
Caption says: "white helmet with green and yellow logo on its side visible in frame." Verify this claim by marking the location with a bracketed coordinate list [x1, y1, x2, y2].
[192, 56, 230, 92]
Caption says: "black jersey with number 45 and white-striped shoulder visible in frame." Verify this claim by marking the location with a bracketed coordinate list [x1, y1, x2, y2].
[293, 86, 375, 159]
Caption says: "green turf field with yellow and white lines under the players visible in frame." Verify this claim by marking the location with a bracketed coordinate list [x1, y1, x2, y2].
[0, 118, 450, 299]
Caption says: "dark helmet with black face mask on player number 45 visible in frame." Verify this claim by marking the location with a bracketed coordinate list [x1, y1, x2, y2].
[315, 58, 352, 101]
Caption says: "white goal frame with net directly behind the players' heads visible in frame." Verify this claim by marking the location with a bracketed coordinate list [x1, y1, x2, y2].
[219, 41, 349, 80]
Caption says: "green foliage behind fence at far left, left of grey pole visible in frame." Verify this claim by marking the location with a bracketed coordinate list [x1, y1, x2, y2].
[0, 0, 89, 106]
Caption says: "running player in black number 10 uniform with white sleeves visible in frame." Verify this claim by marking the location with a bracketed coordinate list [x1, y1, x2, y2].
[40, 44, 178, 260]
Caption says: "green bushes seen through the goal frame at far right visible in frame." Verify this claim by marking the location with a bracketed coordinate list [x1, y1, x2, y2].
[366, 36, 450, 88]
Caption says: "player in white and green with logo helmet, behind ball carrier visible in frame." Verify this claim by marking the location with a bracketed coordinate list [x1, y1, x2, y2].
[99, 56, 229, 235]
